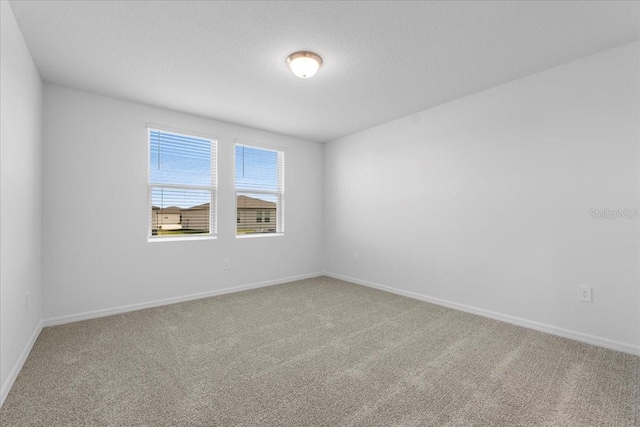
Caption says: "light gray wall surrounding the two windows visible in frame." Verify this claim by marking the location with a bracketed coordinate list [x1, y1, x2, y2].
[43, 84, 323, 319]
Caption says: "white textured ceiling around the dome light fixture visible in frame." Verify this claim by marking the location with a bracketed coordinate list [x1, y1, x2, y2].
[11, 1, 640, 141]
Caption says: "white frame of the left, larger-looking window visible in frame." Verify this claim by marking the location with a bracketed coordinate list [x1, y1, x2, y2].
[146, 124, 219, 242]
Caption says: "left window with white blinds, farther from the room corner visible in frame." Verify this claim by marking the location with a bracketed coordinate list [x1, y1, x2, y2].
[148, 129, 217, 239]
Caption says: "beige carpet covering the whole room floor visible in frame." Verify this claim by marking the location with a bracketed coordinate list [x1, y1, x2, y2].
[0, 278, 640, 427]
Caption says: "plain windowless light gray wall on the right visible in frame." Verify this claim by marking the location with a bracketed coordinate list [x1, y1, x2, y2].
[324, 42, 640, 351]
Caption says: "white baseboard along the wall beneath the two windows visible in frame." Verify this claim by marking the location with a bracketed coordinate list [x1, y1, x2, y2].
[43, 273, 324, 326]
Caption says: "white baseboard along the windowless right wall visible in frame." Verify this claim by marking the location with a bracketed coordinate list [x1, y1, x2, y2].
[324, 272, 640, 355]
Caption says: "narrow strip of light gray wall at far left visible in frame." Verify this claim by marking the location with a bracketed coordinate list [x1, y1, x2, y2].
[0, 1, 42, 402]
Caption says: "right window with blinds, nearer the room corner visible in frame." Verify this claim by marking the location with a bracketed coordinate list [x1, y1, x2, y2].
[235, 143, 284, 236]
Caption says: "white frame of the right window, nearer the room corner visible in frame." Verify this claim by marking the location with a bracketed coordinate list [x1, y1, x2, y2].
[233, 139, 285, 239]
